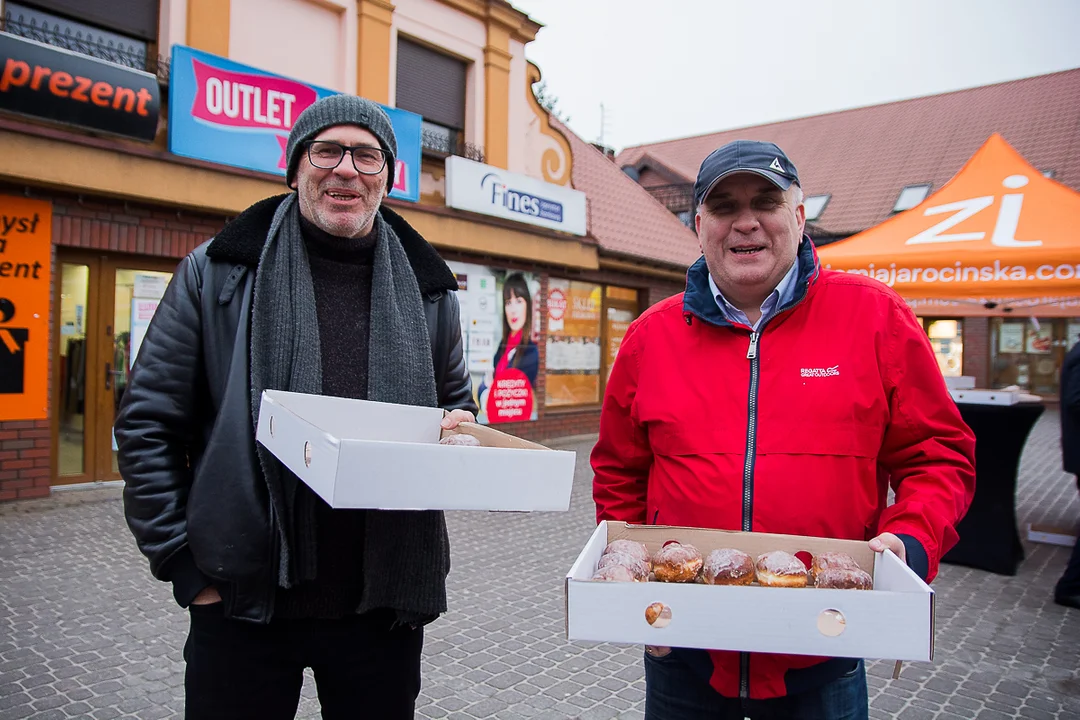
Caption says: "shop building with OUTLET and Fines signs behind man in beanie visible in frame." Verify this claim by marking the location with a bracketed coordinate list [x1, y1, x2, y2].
[0, 0, 698, 501]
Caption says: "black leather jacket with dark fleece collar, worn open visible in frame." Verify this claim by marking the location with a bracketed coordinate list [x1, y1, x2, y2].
[116, 196, 476, 622]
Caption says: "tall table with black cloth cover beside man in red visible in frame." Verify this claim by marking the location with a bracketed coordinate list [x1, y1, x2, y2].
[942, 403, 1043, 575]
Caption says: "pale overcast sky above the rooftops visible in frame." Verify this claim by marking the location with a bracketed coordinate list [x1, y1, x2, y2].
[511, 0, 1080, 149]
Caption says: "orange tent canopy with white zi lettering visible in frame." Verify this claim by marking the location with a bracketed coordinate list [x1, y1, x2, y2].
[819, 134, 1080, 300]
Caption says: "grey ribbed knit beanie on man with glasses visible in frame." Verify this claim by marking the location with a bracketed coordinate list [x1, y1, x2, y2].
[285, 95, 397, 188]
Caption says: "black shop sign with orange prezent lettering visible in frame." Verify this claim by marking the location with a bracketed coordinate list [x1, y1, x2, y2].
[0, 32, 161, 141]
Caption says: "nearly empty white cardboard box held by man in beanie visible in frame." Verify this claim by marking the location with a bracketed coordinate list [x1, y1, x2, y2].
[256, 390, 575, 511]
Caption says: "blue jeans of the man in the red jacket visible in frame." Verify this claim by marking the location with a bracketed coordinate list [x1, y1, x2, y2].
[645, 650, 869, 720]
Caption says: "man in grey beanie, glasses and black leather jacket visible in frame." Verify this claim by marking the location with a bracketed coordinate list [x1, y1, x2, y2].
[116, 95, 475, 719]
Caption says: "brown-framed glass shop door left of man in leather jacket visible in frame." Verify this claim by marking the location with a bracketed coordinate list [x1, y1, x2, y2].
[52, 249, 176, 485]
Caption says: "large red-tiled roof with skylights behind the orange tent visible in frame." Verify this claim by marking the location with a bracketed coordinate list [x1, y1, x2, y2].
[616, 69, 1080, 235]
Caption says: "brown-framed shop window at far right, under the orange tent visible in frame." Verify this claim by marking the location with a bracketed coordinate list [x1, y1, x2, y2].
[990, 317, 1067, 396]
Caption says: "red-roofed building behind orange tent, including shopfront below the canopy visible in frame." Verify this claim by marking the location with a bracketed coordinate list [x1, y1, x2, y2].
[617, 69, 1080, 398]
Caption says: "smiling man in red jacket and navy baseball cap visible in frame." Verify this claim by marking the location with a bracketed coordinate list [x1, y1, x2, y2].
[592, 140, 975, 720]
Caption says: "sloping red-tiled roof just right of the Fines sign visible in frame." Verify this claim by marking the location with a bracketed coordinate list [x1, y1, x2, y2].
[552, 118, 701, 268]
